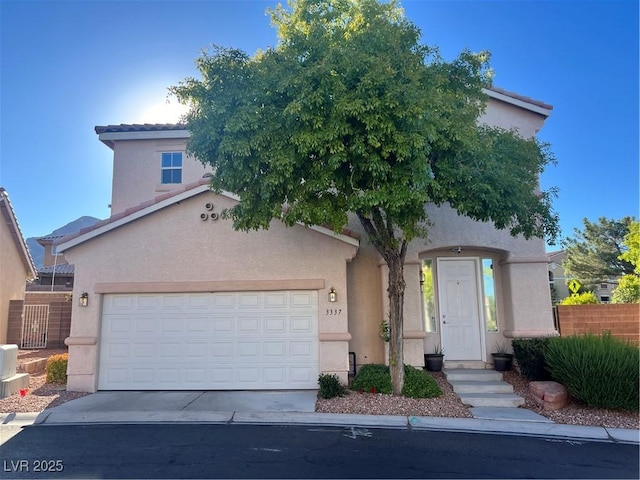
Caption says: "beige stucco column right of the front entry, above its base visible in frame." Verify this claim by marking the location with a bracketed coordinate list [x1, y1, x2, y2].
[500, 257, 557, 338]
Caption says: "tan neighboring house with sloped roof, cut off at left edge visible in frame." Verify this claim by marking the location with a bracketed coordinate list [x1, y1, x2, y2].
[0, 187, 36, 344]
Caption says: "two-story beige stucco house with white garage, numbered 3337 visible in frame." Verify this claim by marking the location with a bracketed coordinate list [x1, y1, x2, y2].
[57, 89, 556, 392]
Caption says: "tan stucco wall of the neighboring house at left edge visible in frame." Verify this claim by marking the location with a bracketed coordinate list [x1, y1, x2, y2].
[0, 219, 28, 344]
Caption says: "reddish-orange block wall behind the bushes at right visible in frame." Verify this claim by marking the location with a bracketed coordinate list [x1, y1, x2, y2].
[556, 303, 640, 345]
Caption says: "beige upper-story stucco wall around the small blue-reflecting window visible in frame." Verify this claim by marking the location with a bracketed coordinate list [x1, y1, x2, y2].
[111, 138, 211, 214]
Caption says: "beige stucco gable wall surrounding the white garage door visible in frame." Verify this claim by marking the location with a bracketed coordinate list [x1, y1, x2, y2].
[65, 191, 357, 391]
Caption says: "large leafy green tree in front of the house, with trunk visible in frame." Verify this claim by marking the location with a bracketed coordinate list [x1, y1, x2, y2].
[170, 0, 558, 394]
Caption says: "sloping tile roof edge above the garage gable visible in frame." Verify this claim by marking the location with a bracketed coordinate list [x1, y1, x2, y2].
[54, 178, 360, 251]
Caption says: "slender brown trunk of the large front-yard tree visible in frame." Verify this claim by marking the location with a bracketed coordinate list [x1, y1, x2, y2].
[387, 254, 405, 395]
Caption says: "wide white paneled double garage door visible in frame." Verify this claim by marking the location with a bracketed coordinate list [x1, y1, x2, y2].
[98, 291, 318, 390]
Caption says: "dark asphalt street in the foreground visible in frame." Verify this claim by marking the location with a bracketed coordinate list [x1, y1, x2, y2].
[0, 423, 640, 479]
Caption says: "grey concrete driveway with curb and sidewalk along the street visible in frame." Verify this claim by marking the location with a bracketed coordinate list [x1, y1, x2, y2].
[0, 390, 640, 444]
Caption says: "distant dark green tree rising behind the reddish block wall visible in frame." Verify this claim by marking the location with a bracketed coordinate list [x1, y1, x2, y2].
[562, 217, 635, 289]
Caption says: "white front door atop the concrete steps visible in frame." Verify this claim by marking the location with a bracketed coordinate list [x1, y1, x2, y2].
[437, 258, 482, 361]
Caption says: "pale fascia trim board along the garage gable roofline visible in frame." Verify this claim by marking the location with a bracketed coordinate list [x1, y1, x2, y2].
[54, 178, 360, 253]
